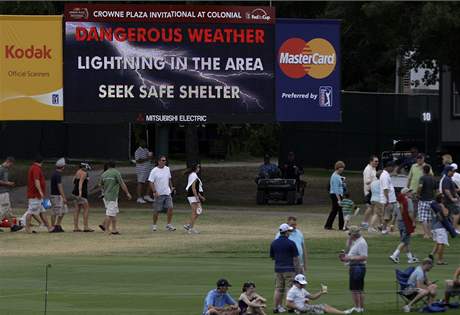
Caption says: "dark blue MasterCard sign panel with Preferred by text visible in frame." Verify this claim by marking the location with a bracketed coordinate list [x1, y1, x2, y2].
[275, 19, 341, 122]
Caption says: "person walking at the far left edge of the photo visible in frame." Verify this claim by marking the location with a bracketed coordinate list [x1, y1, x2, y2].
[0, 156, 23, 232]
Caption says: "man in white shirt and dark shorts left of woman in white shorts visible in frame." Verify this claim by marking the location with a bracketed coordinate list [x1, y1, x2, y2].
[149, 155, 176, 232]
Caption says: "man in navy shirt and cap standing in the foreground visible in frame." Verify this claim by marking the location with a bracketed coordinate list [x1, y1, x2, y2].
[270, 223, 300, 313]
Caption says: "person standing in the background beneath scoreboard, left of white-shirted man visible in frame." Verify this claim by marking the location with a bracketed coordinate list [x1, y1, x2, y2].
[134, 140, 153, 204]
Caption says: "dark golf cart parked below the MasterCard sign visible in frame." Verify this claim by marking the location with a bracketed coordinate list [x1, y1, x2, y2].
[256, 178, 306, 205]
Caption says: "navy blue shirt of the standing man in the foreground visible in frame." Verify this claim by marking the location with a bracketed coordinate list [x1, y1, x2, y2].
[270, 236, 299, 272]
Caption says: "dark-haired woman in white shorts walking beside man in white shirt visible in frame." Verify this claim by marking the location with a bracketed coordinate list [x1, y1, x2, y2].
[184, 164, 206, 234]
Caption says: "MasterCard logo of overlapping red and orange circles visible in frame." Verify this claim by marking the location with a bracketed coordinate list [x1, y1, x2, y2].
[278, 38, 337, 79]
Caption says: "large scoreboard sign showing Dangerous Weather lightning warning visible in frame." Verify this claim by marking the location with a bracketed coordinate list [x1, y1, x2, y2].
[64, 3, 275, 123]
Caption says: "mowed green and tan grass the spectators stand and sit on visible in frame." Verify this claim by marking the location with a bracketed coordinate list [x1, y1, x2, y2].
[0, 205, 460, 315]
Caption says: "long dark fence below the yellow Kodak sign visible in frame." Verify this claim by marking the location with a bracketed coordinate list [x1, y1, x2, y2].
[0, 122, 129, 160]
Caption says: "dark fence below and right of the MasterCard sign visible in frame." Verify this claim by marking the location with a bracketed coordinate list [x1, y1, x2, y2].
[280, 93, 439, 170]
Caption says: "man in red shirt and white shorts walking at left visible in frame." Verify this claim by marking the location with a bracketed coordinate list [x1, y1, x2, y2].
[25, 156, 53, 233]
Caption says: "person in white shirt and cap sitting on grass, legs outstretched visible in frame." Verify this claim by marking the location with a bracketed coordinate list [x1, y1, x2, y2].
[286, 274, 351, 314]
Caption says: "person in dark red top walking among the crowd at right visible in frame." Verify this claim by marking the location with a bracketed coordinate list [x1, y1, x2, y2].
[389, 188, 418, 264]
